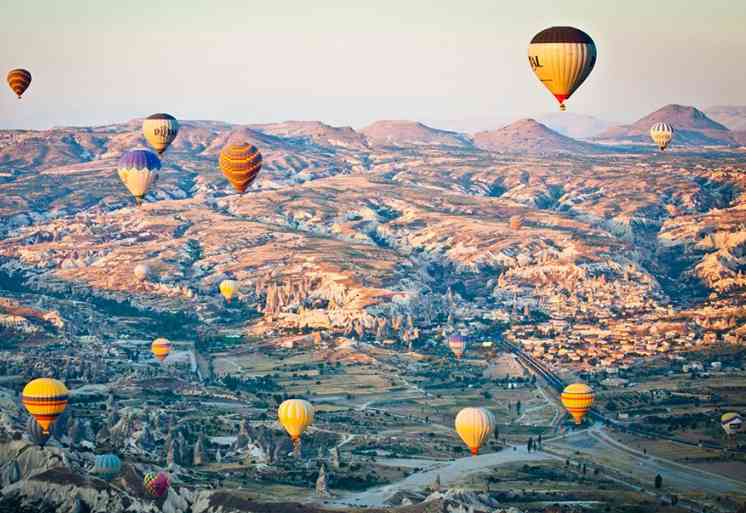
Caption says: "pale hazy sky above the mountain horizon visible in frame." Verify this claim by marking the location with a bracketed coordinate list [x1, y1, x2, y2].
[0, 0, 746, 129]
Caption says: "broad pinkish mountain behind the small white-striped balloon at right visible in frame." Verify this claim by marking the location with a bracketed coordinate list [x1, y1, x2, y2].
[595, 105, 738, 146]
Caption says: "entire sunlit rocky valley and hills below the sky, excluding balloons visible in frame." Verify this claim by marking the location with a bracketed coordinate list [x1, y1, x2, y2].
[0, 106, 746, 513]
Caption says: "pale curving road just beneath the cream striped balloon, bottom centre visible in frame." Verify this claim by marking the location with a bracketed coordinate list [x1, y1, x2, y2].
[334, 447, 552, 507]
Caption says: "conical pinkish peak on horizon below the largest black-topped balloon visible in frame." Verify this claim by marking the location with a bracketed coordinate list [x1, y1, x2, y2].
[474, 119, 603, 153]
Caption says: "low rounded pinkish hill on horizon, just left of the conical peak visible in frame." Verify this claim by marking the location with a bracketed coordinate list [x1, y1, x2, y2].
[360, 121, 473, 148]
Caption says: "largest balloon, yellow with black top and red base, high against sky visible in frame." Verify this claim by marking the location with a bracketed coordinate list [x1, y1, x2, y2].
[528, 27, 596, 110]
